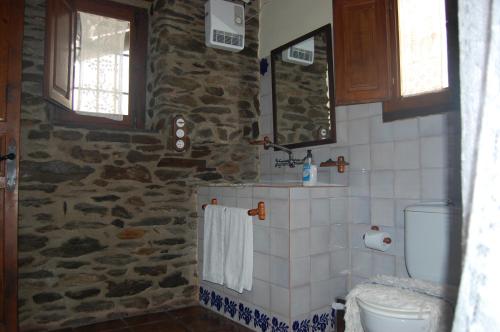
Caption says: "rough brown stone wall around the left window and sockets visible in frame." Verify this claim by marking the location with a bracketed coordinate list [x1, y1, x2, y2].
[19, 0, 259, 331]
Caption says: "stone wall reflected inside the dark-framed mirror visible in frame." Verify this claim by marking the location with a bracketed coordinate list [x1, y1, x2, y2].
[274, 34, 330, 144]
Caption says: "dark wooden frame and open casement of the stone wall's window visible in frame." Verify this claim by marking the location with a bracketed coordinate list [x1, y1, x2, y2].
[44, 0, 148, 129]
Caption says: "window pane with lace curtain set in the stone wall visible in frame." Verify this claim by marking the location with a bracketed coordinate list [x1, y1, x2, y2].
[73, 12, 130, 116]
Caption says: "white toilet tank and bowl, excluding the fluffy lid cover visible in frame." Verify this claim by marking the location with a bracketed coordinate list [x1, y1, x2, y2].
[356, 204, 461, 332]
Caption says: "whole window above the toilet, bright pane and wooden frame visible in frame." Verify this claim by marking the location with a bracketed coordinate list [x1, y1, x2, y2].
[383, 0, 459, 121]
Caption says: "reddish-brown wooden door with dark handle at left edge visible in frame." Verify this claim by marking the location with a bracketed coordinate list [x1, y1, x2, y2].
[0, 0, 24, 332]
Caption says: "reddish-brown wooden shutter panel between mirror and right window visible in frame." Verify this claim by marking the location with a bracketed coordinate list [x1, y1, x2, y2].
[333, 0, 391, 105]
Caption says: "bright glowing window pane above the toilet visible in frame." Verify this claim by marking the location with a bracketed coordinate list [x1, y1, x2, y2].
[398, 0, 448, 96]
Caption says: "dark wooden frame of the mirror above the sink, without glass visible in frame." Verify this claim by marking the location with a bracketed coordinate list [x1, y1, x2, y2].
[271, 24, 337, 149]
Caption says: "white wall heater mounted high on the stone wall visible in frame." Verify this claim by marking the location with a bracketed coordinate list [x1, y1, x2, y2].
[205, 0, 245, 52]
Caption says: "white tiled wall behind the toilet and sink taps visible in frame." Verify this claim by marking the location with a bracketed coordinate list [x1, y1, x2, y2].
[260, 61, 461, 287]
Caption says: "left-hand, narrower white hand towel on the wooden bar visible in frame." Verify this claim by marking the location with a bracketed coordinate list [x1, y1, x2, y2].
[202, 205, 226, 285]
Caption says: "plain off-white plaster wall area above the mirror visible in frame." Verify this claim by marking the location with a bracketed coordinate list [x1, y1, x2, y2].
[259, 0, 333, 58]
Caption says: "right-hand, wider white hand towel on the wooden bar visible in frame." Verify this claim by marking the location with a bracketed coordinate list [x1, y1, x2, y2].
[224, 207, 253, 293]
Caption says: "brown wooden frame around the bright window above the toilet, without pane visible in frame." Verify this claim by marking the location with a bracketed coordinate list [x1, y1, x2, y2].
[383, 0, 460, 121]
